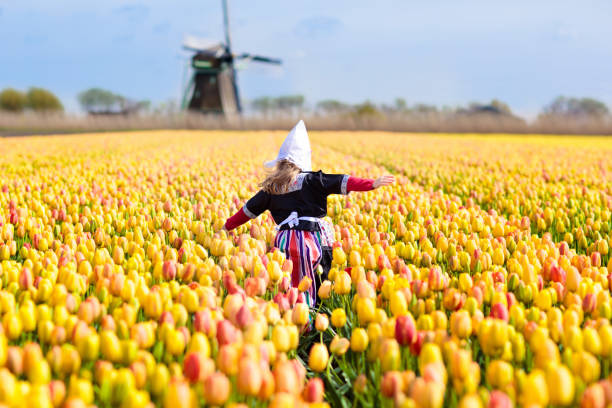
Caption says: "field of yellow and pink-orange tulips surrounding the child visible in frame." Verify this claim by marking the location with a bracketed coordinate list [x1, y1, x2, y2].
[0, 131, 612, 408]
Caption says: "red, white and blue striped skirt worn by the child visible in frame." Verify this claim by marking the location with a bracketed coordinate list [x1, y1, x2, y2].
[274, 229, 323, 307]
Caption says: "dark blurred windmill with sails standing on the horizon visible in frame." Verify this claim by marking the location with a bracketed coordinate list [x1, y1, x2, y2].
[182, 0, 281, 115]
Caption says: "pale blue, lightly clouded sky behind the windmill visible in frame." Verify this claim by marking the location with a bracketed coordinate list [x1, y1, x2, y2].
[0, 0, 612, 117]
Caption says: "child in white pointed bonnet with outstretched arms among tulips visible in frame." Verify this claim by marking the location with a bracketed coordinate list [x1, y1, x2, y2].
[224, 121, 395, 307]
